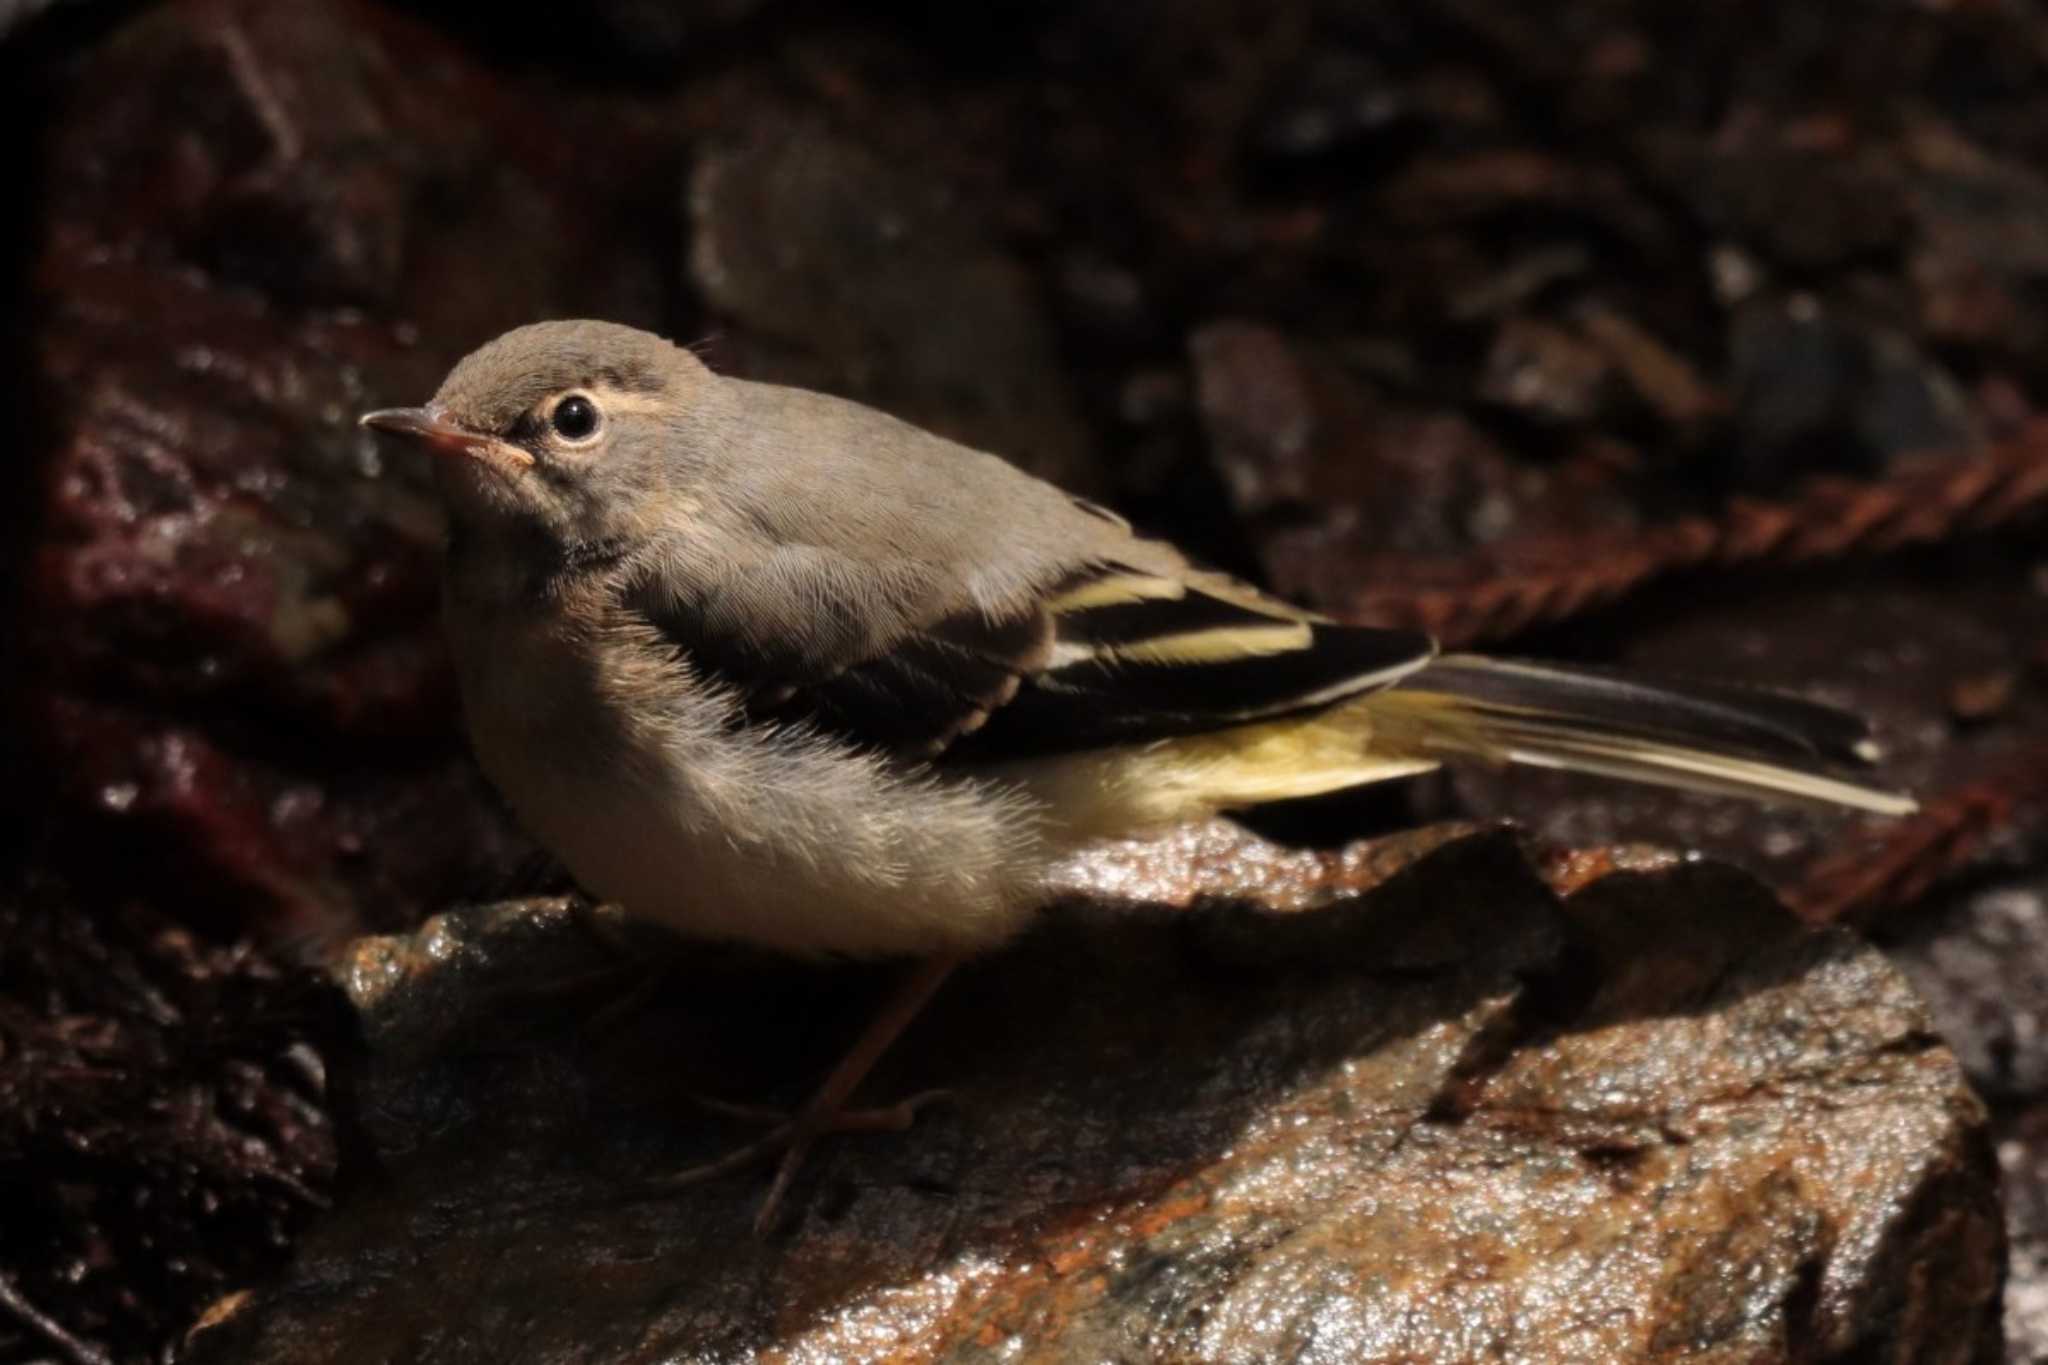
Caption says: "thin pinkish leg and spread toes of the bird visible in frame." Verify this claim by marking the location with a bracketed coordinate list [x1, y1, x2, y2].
[659, 958, 961, 1232]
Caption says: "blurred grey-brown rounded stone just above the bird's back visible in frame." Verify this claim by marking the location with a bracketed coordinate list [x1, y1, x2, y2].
[688, 117, 1100, 487]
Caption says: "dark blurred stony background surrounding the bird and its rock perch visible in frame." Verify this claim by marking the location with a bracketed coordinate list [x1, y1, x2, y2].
[0, 0, 2048, 1361]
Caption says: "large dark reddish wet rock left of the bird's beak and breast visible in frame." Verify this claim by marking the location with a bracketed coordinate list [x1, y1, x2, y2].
[20, 0, 700, 943]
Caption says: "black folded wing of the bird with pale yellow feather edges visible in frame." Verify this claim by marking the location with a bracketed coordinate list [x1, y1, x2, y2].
[629, 563, 1436, 763]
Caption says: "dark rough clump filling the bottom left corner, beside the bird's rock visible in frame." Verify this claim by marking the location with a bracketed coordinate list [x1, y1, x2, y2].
[0, 884, 346, 1361]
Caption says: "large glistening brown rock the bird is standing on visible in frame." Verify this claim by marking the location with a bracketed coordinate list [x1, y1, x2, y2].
[190, 835, 2003, 1363]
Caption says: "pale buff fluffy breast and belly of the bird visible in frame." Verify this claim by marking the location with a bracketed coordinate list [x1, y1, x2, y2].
[463, 622, 1047, 956]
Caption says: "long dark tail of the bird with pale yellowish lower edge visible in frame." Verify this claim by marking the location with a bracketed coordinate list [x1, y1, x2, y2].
[1360, 655, 1917, 814]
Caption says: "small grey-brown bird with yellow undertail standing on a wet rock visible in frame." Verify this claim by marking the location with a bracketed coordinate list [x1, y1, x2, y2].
[360, 319, 1915, 1228]
